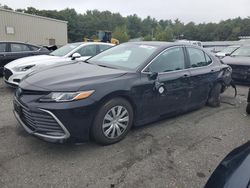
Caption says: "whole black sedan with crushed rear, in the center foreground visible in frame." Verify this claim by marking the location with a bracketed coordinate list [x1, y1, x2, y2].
[14, 42, 231, 145]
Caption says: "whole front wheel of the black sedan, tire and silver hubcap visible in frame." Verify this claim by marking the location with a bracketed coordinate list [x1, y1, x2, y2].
[92, 98, 134, 145]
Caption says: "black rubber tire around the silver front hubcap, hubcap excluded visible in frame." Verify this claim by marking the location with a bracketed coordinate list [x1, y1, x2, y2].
[92, 98, 134, 145]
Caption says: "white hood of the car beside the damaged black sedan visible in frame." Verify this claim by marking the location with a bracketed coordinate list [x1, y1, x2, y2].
[5, 55, 65, 69]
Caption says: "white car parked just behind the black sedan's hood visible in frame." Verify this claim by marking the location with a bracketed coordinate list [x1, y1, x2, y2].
[3, 42, 114, 86]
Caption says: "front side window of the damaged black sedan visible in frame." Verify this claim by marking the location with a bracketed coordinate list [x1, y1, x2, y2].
[148, 47, 185, 73]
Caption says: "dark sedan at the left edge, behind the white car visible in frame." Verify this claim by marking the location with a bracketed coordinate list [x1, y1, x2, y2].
[0, 42, 50, 76]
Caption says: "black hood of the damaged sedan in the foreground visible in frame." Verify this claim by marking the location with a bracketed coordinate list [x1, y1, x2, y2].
[19, 62, 127, 91]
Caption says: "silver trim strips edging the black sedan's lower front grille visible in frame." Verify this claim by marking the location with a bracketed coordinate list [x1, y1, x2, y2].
[14, 97, 70, 140]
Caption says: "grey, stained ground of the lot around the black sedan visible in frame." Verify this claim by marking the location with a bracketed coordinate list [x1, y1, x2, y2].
[0, 79, 250, 188]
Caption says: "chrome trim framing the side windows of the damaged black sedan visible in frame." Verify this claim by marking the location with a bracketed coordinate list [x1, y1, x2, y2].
[141, 45, 214, 75]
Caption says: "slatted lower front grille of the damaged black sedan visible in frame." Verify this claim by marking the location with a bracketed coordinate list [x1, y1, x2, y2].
[20, 108, 65, 136]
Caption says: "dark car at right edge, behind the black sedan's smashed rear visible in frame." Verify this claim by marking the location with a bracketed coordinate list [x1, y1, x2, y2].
[222, 46, 250, 83]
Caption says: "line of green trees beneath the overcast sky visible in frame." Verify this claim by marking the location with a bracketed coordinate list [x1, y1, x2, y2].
[0, 5, 250, 42]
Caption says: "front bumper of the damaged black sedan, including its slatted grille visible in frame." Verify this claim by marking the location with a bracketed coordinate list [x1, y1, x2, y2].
[14, 95, 97, 143]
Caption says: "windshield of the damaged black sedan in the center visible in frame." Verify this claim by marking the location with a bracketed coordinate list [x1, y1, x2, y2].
[88, 43, 157, 70]
